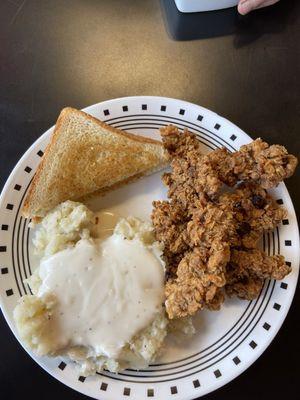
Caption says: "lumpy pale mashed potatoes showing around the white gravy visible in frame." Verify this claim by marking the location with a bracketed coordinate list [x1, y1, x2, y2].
[14, 201, 194, 375]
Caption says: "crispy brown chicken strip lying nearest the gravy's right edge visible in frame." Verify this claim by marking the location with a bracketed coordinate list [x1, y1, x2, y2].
[166, 204, 234, 318]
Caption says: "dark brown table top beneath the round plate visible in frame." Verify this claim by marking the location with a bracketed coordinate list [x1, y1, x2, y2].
[0, 0, 300, 400]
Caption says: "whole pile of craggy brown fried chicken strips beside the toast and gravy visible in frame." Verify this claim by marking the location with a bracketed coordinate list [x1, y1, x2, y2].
[152, 126, 297, 318]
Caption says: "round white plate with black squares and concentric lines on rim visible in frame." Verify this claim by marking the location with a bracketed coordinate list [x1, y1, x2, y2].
[0, 97, 299, 400]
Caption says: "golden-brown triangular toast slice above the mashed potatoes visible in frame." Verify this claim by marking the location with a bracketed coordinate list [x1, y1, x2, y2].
[23, 108, 167, 219]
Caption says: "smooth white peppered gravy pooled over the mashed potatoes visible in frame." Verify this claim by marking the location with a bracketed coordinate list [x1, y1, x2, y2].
[38, 234, 164, 358]
